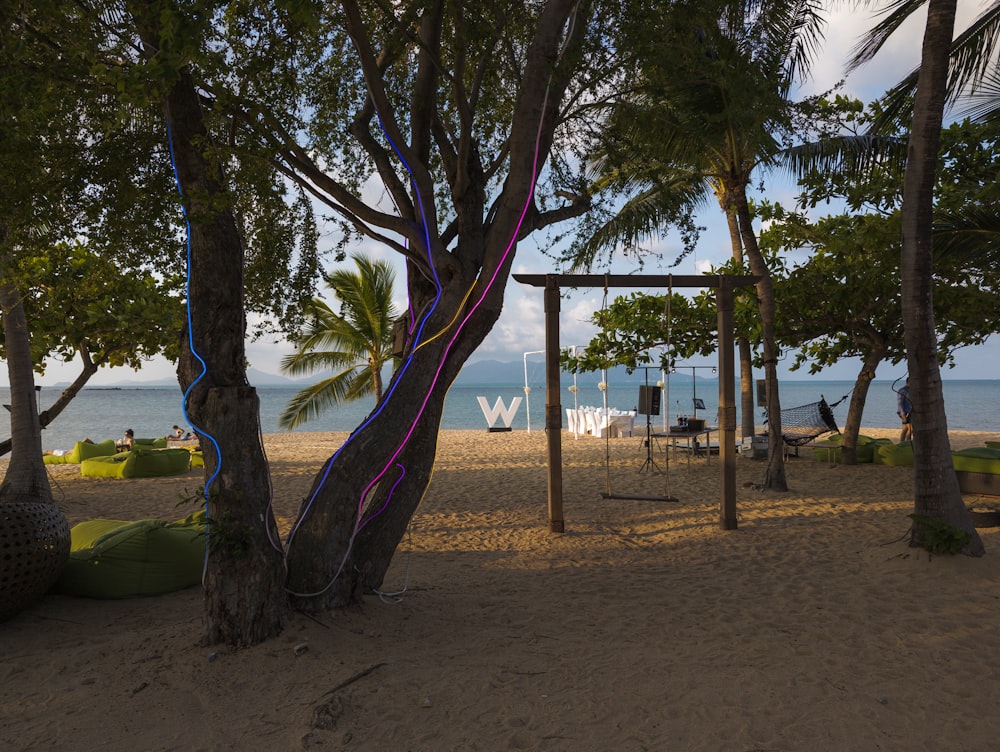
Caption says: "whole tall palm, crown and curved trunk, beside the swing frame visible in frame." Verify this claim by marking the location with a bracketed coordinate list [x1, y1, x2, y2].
[575, 0, 822, 490]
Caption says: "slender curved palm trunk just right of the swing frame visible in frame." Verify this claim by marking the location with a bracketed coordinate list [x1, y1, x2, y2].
[733, 194, 788, 491]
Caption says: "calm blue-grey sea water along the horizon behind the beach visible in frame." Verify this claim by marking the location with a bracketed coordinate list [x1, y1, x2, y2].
[0, 374, 1000, 449]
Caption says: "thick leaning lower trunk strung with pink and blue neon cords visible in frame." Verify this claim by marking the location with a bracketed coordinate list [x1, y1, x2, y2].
[288, 274, 494, 611]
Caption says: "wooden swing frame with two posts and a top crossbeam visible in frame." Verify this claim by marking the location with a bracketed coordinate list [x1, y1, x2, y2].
[513, 274, 757, 533]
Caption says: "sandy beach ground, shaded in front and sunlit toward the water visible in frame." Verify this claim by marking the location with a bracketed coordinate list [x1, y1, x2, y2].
[0, 429, 1000, 752]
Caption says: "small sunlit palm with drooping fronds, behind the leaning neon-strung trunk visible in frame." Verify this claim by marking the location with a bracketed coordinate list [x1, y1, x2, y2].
[279, 256, 398, 429]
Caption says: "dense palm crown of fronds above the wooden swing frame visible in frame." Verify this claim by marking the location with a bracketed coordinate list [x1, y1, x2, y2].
[568, 0, 820, 268]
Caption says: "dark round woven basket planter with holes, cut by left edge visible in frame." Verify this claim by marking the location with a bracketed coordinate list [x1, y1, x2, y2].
[0, 501, 70, 621]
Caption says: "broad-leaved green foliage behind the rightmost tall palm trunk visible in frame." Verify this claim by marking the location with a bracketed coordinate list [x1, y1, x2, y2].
[759, 106, 1000, 375]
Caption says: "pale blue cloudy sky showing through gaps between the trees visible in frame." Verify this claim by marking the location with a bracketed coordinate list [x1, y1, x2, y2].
[21, 0, 1000, 386]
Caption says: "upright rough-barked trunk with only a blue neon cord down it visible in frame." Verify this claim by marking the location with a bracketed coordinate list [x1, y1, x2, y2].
[150, 45, 288, 646]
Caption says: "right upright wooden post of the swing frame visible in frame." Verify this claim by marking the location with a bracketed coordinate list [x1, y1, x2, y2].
[715, 275, 736, 530]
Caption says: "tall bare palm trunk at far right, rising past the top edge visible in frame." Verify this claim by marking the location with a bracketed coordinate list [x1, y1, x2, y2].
[900, 0, 985, 556]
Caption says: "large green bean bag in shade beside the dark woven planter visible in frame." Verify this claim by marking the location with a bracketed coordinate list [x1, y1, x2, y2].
[55, 511, 205, 598]
